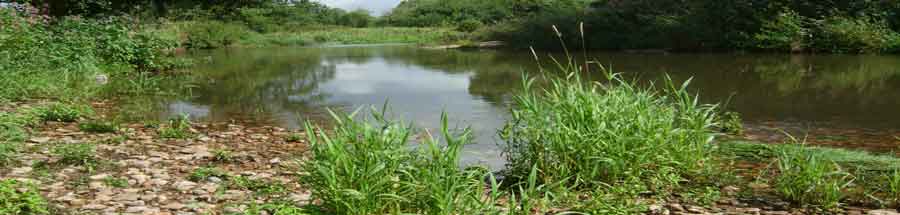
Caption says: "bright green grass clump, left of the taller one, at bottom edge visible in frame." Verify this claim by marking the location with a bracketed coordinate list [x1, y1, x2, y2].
[300, 111, 496, 214]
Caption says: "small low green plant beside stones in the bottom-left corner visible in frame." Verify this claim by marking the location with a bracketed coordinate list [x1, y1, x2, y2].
[0, 179, 50, 214]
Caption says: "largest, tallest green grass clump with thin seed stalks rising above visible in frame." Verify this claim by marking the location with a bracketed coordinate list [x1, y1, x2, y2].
[501, 66, 716, 194]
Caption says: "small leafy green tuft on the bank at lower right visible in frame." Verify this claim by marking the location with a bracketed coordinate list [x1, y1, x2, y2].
[774, 146, 853, 209]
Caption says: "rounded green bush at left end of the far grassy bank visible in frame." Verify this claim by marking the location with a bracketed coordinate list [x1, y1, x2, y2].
[185, 21, 247, 49]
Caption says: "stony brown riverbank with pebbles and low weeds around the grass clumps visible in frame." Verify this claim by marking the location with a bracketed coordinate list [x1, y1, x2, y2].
[0, 101, 900, 214]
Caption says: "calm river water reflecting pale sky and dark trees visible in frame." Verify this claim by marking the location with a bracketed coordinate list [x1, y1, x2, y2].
[130, 46, 900, 167]
